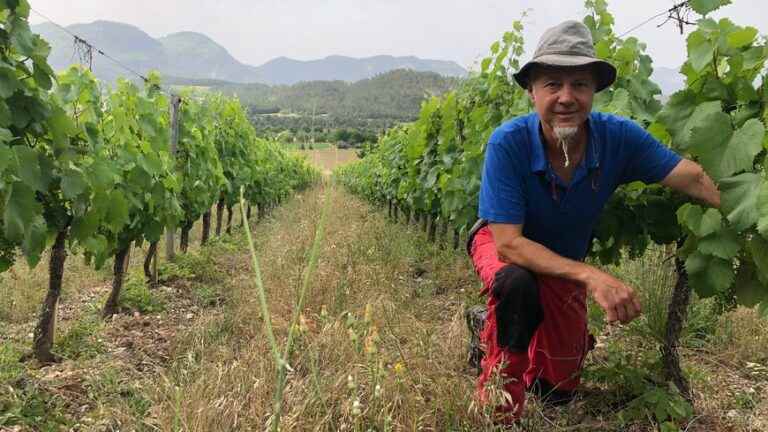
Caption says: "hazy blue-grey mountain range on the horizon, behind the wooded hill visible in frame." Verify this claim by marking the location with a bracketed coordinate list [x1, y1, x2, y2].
[32, 21, 467, 85]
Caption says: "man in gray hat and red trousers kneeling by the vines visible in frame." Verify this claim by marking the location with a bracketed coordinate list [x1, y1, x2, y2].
[469, 21, 720, 421]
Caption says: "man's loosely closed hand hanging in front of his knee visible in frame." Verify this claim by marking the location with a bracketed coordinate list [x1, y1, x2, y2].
[582, 266, 642, 324]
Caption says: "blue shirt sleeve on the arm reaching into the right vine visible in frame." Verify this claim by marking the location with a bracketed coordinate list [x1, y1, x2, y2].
[621, 120, 682, 184]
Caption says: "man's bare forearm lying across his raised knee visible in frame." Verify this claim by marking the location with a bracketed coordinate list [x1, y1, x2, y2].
[497, 236, 588, 282]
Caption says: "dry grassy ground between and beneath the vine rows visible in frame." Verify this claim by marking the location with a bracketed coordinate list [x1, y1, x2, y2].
[0, 180, 768, 431]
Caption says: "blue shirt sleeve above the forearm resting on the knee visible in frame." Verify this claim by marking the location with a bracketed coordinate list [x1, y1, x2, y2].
[478, 127, 526, 225]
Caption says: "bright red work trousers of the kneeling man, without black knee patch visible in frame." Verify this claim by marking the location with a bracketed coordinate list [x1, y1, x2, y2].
[470, 226, 591, 418]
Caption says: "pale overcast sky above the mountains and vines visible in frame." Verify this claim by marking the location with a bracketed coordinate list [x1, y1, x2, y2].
[30, 0, 768, 67]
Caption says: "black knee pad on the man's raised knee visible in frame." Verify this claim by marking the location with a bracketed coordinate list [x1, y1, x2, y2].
[492, 264, 544, 352]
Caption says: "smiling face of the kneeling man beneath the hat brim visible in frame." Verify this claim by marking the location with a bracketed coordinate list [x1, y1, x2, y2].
[528, 67, 595, 130]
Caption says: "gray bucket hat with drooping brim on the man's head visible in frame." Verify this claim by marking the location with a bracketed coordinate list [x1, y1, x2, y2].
[514, 20, 616, 91]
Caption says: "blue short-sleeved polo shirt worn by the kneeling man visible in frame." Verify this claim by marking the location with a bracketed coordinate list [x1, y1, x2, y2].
[478, 112, 681, 260]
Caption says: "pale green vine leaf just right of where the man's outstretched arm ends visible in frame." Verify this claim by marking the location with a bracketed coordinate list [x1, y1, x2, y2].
[720, 173, 765, 232]
